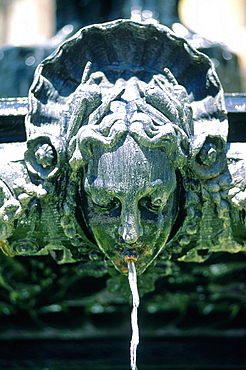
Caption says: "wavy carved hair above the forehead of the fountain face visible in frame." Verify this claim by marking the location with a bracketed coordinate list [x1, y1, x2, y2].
[69, 70, 193, 170]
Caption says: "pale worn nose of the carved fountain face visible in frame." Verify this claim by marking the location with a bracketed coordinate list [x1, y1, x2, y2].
[118, 202, 143, 244]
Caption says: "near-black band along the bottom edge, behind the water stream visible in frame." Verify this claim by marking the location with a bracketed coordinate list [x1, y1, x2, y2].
[0, 337, 246, 370]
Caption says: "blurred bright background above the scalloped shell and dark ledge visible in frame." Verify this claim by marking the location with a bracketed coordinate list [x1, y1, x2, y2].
[0, 0, 246, 97]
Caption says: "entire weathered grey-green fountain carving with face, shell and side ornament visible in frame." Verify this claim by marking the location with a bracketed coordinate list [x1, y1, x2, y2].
[0, 20, 246, 274]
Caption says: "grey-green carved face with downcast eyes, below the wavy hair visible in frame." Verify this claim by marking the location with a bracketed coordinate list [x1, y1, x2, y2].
[84, 137, 176, 274]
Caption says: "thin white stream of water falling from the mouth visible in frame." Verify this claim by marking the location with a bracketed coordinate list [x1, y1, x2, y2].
[128, 261, 139, 370]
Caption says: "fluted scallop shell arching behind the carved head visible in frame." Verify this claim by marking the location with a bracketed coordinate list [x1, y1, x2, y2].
[26, 20, 227, 145]
